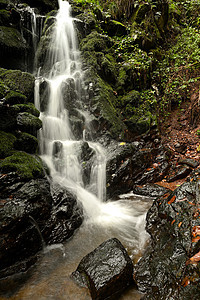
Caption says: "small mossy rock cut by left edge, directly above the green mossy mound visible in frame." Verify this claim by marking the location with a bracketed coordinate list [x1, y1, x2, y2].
[0, 131, 16, 158]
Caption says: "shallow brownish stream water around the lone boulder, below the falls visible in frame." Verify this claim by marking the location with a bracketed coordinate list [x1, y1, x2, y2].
[0, 194, 152, 300]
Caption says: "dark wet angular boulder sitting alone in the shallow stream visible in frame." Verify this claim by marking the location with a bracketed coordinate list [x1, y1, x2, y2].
[72, 238, 133, 300]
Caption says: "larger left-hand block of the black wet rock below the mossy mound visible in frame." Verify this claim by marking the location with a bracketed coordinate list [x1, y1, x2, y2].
[0, 174, 51, 277]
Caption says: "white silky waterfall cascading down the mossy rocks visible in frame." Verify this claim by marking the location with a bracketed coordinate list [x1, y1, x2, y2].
[35, 0, 148, 251]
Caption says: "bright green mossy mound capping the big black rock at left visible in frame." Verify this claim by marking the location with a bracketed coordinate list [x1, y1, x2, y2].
[0, 151, 44, 180]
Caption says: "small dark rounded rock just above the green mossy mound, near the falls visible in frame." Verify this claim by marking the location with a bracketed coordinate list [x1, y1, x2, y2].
[14, 132, 38, 154]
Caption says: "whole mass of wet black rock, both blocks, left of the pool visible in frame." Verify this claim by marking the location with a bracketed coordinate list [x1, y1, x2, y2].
[0, 173, 83, 278]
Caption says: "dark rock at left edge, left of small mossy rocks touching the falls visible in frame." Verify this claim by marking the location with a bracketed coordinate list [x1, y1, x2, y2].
[0, 105, 19, 131]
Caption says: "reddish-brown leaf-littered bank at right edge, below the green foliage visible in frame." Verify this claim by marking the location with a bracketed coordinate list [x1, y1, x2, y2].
[158, 88, 200, 190]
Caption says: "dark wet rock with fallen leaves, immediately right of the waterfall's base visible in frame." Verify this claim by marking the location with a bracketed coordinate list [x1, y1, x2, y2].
[107, 143, 170, 197]
